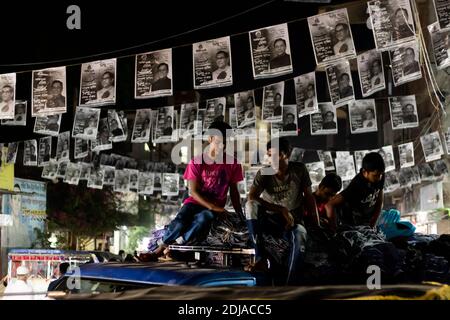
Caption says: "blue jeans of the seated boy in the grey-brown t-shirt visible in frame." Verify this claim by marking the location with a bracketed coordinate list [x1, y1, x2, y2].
[245, 201, 307, 284]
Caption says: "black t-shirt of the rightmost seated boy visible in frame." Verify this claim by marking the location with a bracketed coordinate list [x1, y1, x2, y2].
[341, 173, 384, 225]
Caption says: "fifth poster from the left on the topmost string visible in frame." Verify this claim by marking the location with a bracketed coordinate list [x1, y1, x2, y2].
[192, 37, 233, 89]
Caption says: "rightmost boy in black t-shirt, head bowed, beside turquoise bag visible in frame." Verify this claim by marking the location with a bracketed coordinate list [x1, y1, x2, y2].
[325, 152, 385, 229]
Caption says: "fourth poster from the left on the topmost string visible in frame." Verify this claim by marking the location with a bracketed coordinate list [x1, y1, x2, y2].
[134, 49, 173, 99]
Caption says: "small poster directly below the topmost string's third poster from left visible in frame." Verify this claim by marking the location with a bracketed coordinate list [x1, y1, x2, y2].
[72, 107, 101, 140]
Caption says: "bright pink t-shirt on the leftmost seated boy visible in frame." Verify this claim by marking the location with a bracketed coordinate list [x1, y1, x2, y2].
[184, 154, 244, 207]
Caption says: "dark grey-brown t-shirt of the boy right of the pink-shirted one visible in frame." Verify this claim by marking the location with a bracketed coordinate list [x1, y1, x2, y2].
[253, 162, 311, 211]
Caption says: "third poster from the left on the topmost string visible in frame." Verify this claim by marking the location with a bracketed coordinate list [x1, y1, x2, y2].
[80, 59, 116, 106]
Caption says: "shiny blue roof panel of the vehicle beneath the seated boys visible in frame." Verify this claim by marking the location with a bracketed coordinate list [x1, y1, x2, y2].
[66, 262, 256, 285]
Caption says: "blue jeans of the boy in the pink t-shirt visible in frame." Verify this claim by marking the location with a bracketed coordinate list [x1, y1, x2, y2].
[163, 203, 215, 244]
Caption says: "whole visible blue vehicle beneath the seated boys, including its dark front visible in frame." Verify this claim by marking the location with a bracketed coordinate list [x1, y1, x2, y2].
[48, 262, 262, 293]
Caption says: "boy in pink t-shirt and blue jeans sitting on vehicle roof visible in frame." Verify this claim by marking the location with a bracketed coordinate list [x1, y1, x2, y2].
[151, 121, 244, 258]
